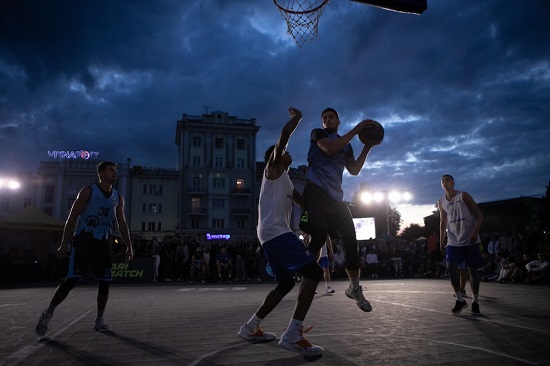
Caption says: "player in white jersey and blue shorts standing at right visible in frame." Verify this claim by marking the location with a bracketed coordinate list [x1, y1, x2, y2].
[437, 174, 483, 315]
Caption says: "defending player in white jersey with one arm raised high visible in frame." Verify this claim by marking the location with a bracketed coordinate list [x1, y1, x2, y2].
[238, 107, 324, 356]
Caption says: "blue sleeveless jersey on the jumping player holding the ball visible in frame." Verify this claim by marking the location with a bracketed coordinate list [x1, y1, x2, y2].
[306, 128, 353, 201]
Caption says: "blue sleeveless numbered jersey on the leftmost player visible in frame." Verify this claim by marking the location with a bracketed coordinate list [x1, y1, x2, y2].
[76, 184, 119, 240]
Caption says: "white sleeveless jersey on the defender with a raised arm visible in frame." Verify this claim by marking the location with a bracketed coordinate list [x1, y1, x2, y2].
[257, 170, 294, 244]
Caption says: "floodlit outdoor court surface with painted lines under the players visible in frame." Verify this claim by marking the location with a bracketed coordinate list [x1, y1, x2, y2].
[0, 279, 550, 366]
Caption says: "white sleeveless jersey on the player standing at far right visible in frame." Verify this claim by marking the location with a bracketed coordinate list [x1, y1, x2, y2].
[439, 191, 481, 246]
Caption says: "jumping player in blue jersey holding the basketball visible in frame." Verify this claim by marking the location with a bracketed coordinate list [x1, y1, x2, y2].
[300, 108, 375, 311]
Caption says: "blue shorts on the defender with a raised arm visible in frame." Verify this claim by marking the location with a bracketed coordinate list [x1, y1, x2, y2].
[262, 233, 317, 280]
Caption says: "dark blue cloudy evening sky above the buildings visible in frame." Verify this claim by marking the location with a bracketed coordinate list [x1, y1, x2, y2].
[0, 0, 550, 227]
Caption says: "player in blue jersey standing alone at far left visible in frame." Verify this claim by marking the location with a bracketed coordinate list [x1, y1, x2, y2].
[35, 161, 134, 336]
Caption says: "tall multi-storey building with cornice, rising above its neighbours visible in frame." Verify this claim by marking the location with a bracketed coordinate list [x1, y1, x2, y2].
[175, 112, 260, 239]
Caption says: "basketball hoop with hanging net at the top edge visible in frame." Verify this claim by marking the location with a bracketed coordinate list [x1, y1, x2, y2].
[273, 0, 329, 48]
